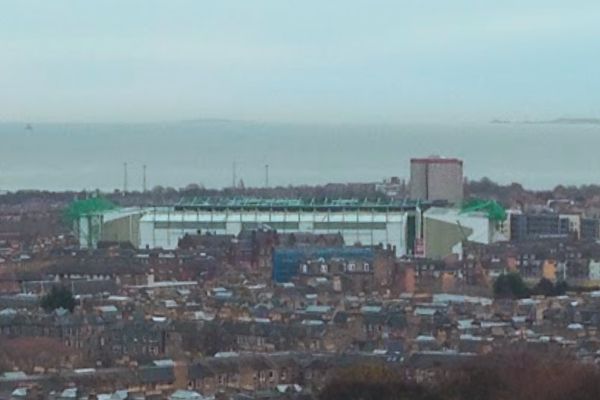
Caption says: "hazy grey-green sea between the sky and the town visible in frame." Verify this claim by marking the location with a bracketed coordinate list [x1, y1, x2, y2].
[0, 121, 600, 190]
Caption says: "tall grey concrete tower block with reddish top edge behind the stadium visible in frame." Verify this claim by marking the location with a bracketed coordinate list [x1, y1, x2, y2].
[410, 156, 464, 203]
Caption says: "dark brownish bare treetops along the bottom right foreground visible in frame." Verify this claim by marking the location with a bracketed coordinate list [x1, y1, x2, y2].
[319, 351, 600, 400]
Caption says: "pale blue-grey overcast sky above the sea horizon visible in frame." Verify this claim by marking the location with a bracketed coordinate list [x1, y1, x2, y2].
[0, 0, 600, 123]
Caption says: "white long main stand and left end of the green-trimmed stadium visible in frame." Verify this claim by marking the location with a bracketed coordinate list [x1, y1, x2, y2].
[73, 198, 431, 255]
